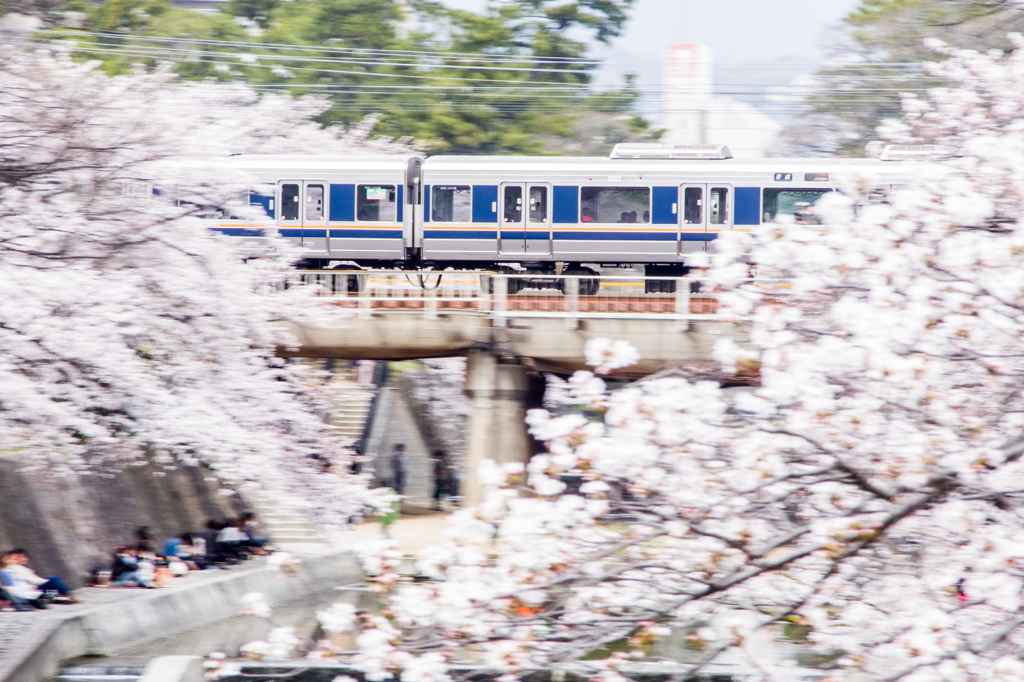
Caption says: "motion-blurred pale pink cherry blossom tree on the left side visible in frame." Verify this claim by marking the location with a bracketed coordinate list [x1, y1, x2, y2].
[0, 47, 410, 514]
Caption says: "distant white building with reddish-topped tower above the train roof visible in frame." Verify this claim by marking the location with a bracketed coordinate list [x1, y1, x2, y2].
[662, 45, 782, 159]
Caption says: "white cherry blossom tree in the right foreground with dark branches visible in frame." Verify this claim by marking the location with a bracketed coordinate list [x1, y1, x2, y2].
[342, 36, 1024, 682]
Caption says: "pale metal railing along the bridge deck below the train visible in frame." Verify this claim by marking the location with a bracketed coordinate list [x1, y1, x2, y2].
[281, 270, 733, 330]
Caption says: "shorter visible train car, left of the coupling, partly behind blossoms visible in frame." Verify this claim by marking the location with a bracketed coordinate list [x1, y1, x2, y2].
[210, 155, 423, 268]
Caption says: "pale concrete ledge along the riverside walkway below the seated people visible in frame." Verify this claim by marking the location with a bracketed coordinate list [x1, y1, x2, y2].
[0, 550, 362, 682]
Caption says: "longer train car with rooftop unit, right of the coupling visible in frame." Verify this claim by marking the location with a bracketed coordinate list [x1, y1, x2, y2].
[416, 144, 905, 274]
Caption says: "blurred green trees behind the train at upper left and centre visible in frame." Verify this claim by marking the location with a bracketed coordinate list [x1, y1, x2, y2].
[24, 0, 654, 154]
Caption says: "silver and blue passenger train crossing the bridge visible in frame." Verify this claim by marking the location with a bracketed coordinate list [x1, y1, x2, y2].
[199, 143, 918, 276]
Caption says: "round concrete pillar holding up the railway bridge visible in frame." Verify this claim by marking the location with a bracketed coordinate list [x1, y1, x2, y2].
[461, 349, 543, 506]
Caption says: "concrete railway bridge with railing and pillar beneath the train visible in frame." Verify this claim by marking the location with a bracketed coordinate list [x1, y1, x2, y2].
[279, 270, 743, 504]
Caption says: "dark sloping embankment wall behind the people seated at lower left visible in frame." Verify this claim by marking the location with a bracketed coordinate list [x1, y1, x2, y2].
[0, 450, 248, 587]
